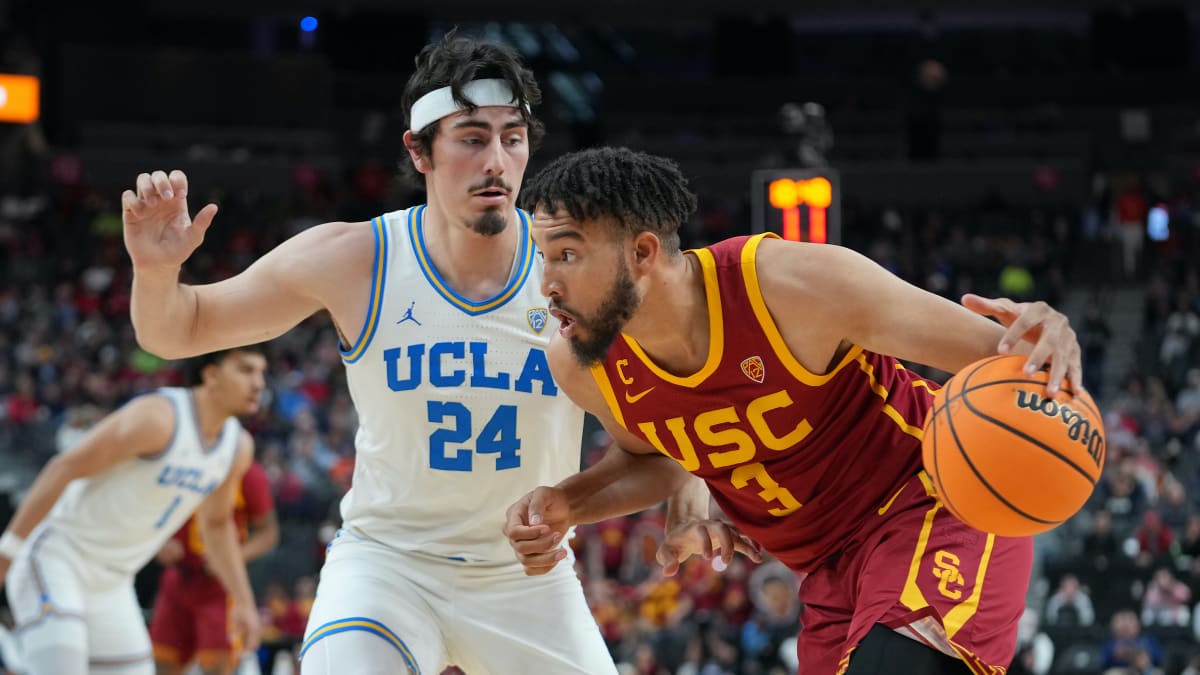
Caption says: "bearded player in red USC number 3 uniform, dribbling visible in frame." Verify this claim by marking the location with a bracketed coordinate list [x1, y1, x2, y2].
[505, 149, 1081, 675]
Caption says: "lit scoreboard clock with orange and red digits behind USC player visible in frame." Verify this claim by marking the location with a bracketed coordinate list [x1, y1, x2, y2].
[750, 169, 841, 244]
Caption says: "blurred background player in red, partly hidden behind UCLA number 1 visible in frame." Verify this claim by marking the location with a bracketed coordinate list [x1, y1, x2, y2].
[150, 446, 280, 675]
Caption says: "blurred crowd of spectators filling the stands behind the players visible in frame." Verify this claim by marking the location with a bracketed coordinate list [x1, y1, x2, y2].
[0, 117, 1200, 675]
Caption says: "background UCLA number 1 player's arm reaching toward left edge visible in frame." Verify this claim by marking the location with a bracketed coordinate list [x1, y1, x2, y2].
[0, 394, 175, 586]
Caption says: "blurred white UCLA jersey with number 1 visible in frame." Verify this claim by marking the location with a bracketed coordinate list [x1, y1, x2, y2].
[44, 388, 241, 574]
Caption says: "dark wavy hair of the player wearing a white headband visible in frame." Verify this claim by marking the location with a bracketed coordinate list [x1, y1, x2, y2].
[400, 29, 545, 185]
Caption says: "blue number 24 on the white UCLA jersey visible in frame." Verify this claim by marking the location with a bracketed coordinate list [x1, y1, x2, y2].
[428, 401, 521, 471]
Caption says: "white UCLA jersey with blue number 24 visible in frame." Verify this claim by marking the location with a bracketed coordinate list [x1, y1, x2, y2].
[342, 205, 583, 562]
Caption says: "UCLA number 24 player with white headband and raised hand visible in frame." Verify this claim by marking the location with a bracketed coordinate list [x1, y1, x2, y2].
[122, 30, 708, 675]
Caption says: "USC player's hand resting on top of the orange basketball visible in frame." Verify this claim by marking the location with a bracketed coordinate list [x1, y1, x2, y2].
[962, 293, 1084, 396]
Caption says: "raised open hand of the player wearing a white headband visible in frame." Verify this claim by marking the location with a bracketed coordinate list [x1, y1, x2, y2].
[121, 169, 217, 269]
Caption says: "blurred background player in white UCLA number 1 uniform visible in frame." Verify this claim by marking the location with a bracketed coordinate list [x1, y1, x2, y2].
[0, 348, 266, 675]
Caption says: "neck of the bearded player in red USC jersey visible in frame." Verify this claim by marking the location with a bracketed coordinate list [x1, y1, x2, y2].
[624, 255, 710, 377]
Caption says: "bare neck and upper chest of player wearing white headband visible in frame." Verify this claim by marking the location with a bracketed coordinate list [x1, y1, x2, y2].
[421, 201, 521, 301]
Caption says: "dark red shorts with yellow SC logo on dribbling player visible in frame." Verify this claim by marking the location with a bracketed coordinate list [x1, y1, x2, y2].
[798, 472, 1033, 675]
